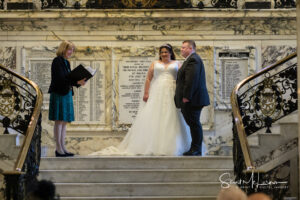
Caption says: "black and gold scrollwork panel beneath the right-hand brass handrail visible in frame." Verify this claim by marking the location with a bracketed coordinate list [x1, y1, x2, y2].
[237, 55, 297, 136]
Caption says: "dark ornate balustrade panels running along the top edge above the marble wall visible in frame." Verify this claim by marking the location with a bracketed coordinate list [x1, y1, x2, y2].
[0, 0, 296, 10]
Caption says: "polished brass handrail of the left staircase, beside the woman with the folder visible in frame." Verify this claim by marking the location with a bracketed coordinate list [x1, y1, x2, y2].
[0, 64, 43, 174]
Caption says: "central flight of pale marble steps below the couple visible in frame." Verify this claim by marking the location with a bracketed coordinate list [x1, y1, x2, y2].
[39, 156, 234, 200]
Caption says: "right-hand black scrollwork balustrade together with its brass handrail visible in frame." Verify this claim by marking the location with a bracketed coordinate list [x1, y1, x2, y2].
[231, 53, 298, 199]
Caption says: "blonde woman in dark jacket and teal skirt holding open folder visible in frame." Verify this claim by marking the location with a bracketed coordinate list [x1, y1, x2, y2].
[48, 41, 85, 157]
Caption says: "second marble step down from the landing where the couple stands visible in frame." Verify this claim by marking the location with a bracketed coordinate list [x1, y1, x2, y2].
[39, 169, 233, 183]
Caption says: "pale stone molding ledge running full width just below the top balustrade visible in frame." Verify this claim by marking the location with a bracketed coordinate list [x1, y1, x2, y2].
[0, 8, 296, 20]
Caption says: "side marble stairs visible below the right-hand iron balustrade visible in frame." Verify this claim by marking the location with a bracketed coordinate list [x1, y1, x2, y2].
[249, 112, 299, 199]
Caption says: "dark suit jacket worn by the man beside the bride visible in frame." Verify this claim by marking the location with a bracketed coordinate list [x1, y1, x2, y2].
[174, 53, 209, 108]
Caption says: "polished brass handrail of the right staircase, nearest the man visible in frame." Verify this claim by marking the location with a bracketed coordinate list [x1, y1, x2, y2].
[230, 53, 297, 171]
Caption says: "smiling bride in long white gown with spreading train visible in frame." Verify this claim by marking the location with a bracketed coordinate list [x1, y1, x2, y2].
[90, 44, 191, 156]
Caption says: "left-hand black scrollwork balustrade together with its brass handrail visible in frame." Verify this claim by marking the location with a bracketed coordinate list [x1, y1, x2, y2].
[0, 65, 43, 200]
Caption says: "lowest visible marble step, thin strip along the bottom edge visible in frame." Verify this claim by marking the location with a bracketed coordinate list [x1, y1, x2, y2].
[60, 196, 217, 200]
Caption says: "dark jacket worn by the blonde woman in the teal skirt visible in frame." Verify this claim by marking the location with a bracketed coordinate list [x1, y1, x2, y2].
[48, 56, 79, 95]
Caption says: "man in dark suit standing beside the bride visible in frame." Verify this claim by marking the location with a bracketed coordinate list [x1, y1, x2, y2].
[174, 40, 209, 156]
